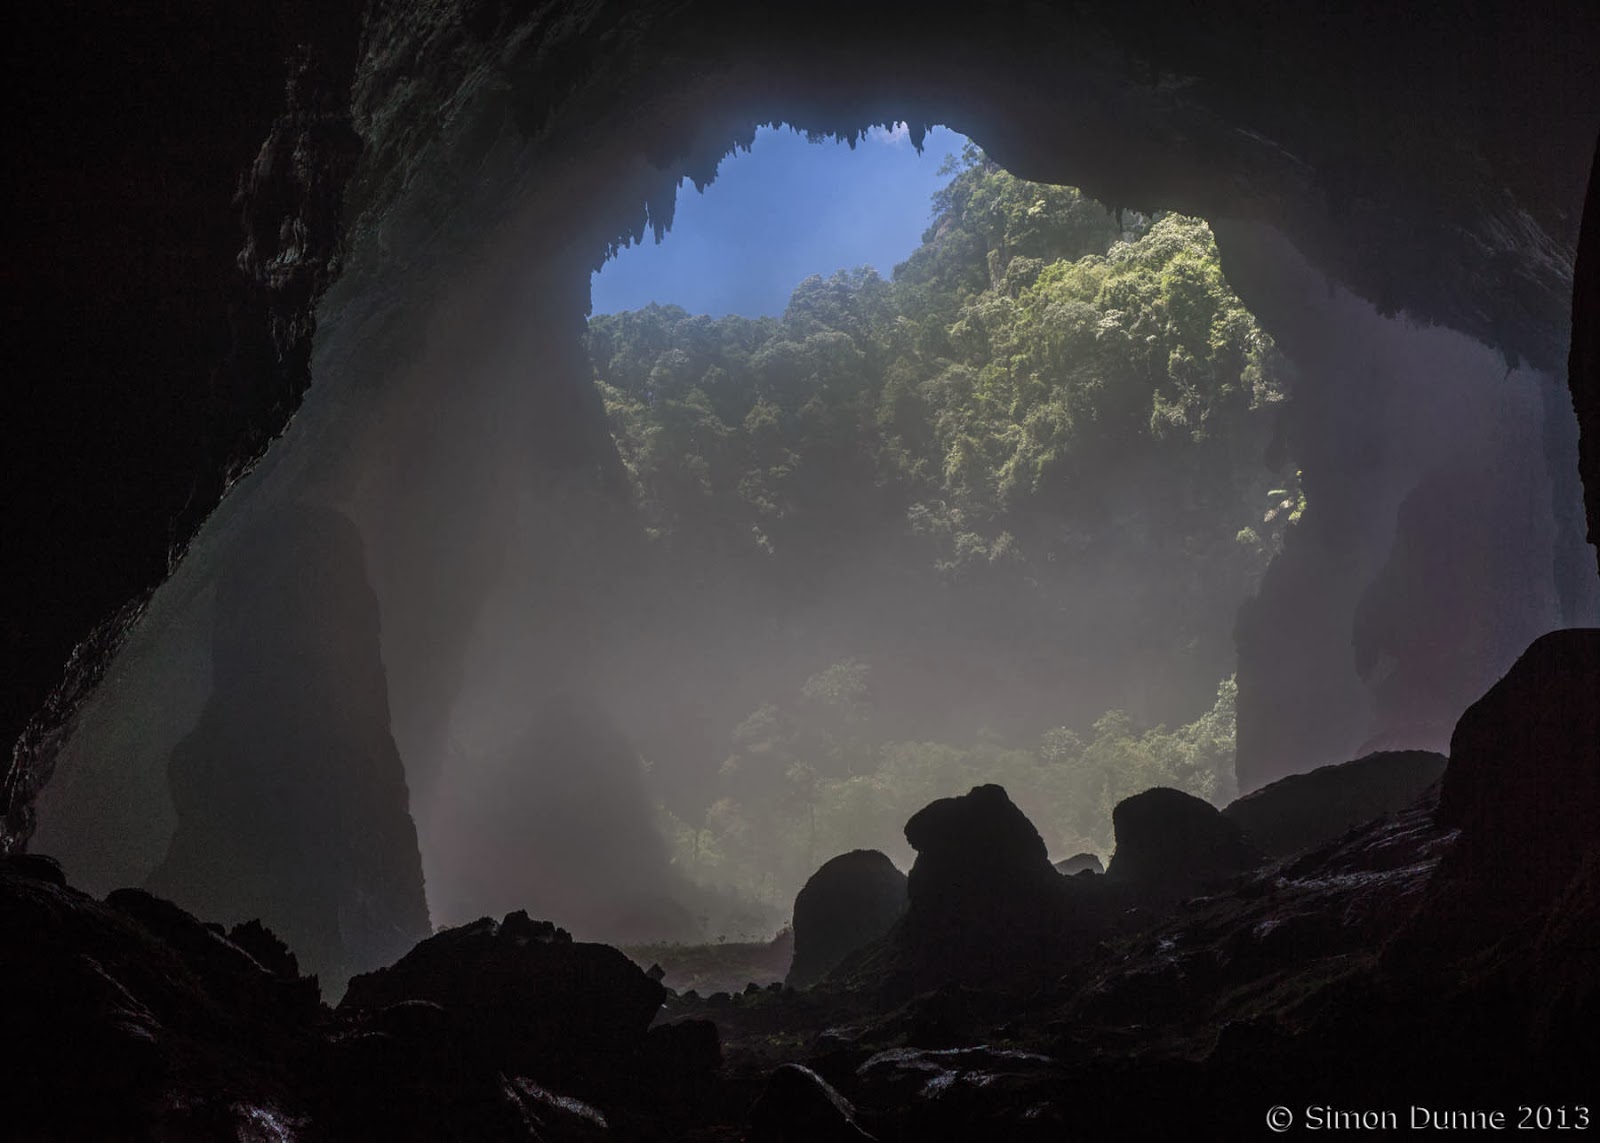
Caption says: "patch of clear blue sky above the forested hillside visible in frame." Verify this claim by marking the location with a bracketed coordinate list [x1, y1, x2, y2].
[594, 125, 966, 317]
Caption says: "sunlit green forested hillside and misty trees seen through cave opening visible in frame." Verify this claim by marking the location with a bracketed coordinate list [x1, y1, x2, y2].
[589, 147, 1304, 908]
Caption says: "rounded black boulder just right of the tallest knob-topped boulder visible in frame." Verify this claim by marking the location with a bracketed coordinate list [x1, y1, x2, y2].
[1106, 786, 1262, 896]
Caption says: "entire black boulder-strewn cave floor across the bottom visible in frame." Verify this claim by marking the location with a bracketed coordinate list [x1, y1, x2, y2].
[0, 631, 1600, 1141]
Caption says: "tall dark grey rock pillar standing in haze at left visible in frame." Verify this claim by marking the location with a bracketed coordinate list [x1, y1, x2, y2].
[149, 506, 429, 993]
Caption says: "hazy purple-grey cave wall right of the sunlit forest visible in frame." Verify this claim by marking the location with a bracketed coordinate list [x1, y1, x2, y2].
[1216, 223, 1600, 791]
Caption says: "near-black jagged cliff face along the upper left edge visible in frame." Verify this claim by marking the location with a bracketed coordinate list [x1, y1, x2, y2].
[0, 3, 360, 848]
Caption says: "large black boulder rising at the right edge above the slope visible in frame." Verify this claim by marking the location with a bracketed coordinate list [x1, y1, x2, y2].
[1438, 628, 1600, 911]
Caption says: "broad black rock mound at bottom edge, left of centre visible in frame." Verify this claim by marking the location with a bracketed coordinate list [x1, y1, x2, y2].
[325, 912, 720, 1140]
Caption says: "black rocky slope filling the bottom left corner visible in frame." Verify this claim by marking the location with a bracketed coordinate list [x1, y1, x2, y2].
[0, 858, 323, 1140]
